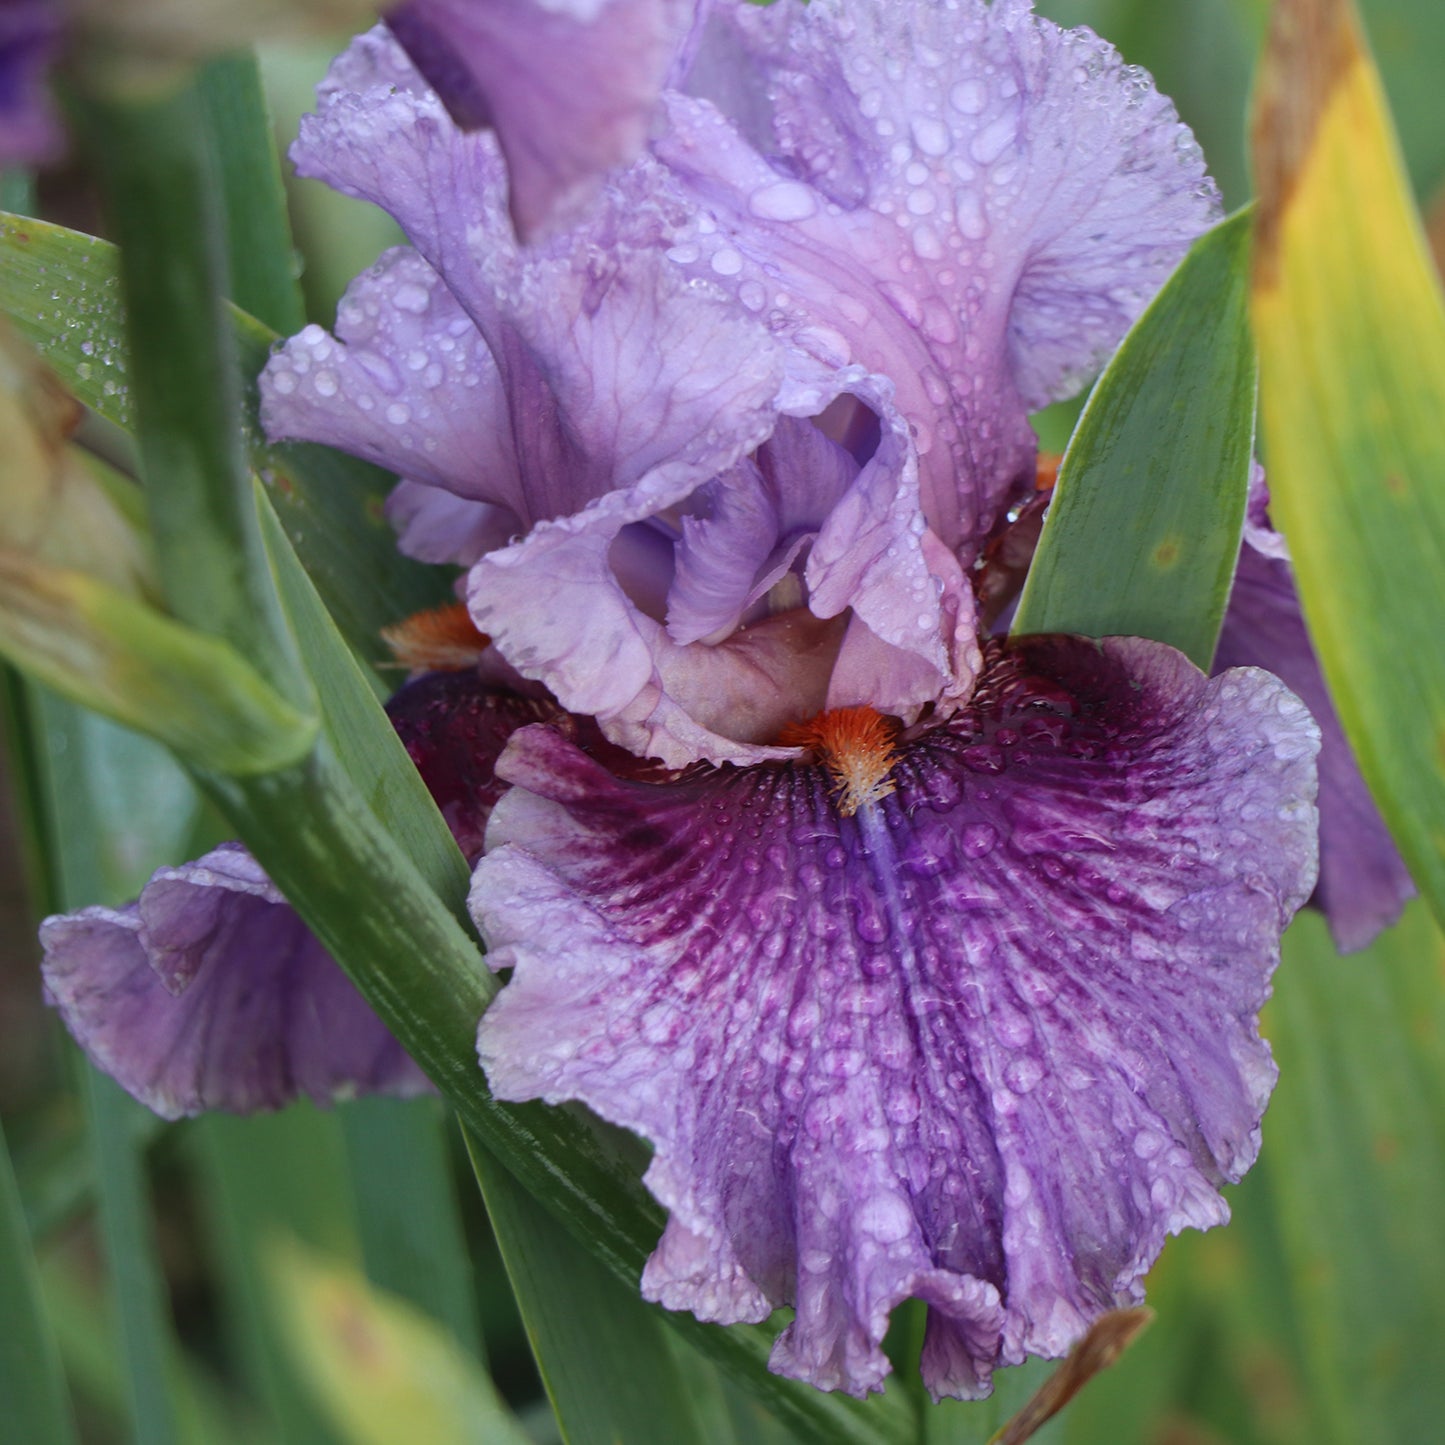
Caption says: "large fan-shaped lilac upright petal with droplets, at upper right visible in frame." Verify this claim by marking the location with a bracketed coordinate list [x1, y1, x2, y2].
[656, 0, 1217, 545]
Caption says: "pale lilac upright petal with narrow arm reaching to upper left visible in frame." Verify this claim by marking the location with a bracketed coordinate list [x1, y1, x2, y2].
[293, 32, 797, 523]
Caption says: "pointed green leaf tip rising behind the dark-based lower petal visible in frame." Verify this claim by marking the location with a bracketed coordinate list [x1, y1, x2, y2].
[1013, 203, 1256, 668]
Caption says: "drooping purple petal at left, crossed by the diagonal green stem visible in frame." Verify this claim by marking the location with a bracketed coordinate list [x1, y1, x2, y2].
[40, 670, 556, 1118]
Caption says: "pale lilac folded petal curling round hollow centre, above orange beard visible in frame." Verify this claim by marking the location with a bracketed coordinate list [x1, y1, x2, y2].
[468, 374, 977, 767]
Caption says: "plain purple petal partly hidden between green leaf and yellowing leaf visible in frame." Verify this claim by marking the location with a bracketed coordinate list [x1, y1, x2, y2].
[1214, 531, 1415, 952]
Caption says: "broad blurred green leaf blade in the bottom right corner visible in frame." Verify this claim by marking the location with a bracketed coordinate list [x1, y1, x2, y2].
[1260, 903, 1445, 1445]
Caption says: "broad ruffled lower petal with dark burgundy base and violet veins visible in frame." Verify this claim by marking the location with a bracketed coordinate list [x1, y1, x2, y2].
[471, 639, 1318, 1396]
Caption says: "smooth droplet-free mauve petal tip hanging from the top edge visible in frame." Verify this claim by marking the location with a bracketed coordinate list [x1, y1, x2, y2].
[387, 0, 696, 237]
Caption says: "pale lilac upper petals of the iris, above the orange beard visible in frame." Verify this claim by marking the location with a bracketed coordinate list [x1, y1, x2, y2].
[263, 0, 1217, 766]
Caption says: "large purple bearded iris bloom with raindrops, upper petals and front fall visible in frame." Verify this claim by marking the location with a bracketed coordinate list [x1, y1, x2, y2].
[33, 0, 1318, 1396]
